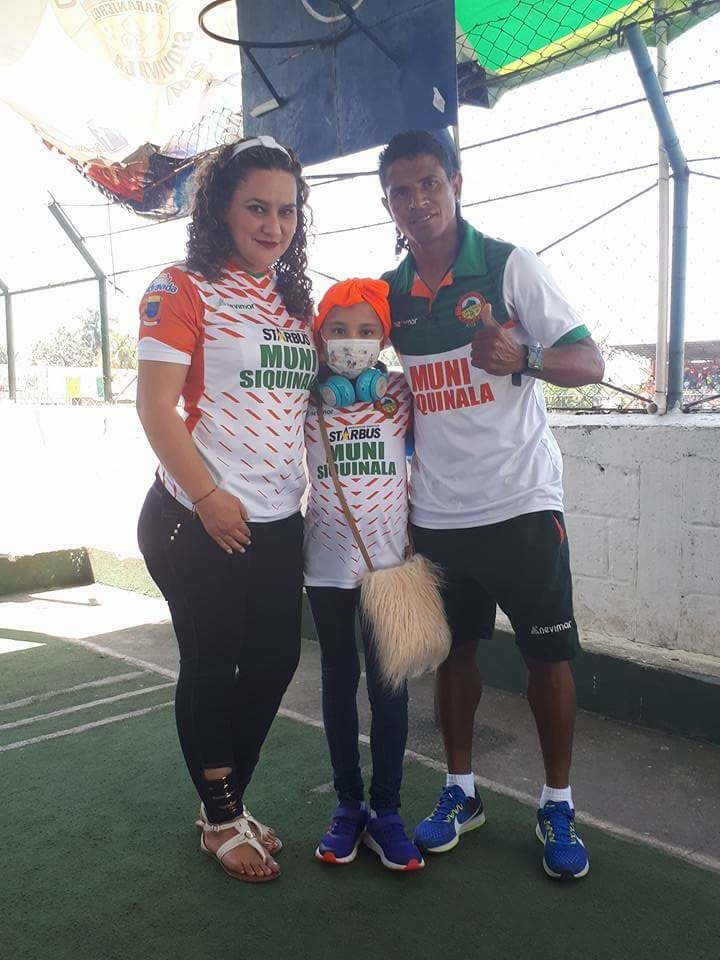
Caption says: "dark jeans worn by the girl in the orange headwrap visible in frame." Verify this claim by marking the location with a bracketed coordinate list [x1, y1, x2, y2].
[307, 587, 408, 812]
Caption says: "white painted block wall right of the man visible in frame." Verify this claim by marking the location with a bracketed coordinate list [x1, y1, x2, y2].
[551, 414, 720, 656]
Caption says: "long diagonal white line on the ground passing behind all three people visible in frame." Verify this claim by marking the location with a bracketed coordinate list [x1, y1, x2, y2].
[49, 640, 720, 873]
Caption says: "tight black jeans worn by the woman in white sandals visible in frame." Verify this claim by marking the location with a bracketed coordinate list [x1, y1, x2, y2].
[138, 479, 302, 822]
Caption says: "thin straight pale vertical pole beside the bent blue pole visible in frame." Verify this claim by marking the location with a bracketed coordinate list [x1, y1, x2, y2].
[655, 0, 670, 413]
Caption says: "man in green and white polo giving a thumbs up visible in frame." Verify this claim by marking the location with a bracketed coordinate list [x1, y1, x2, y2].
[379, 132, 604, 879]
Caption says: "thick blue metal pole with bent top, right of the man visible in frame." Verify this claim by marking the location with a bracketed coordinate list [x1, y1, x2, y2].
[626, 23, 690, 412]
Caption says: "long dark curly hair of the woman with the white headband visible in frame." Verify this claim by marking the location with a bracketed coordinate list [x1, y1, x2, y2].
[187, 144, 313, 317]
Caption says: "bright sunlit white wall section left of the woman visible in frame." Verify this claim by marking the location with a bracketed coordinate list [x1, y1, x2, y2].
[0, 402, 156, 556]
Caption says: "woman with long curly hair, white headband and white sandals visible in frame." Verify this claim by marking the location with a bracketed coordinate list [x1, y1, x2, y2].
[137, 137, 317, 882]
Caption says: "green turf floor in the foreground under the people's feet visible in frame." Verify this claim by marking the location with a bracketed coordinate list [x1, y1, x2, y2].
[0, 640, 720, 960]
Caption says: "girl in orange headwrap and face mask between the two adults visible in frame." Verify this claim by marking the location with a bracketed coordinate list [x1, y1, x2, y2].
[305, 279, 424, 870]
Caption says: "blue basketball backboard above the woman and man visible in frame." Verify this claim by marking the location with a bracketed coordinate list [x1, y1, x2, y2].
[236, 0, 457, 165]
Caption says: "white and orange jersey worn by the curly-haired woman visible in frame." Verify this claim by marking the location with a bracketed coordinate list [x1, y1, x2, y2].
[138, 258, 318, 521]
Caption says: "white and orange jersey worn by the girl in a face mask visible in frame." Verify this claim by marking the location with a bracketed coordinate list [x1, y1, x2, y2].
[305, 374, 412, 588]
